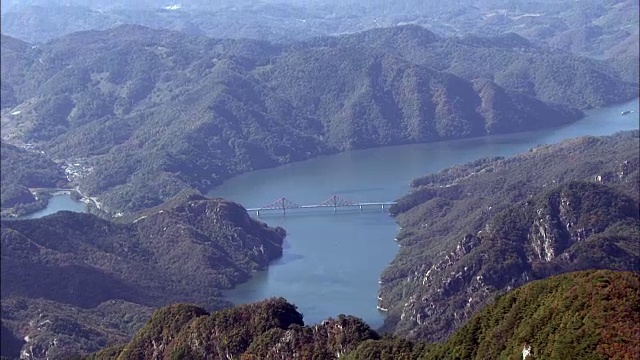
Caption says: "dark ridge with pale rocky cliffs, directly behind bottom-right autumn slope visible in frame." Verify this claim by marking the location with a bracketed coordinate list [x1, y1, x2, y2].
[383, 182, 640, 341]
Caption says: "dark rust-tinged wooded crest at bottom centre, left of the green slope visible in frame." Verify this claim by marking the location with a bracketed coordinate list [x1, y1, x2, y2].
[93, 299, 378, 359]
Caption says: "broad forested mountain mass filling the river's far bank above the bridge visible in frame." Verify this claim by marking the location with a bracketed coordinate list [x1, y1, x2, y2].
[2, 26, 637, 217]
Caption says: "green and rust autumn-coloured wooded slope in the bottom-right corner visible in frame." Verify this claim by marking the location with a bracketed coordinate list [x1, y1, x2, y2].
[346, 270, 640, 360]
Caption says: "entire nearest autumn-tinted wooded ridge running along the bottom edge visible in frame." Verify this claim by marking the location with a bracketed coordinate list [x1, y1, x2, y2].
[79, 271, 640, 360]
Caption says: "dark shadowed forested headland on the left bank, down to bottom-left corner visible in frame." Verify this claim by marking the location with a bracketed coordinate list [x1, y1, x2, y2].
[0, 194, 285, 358]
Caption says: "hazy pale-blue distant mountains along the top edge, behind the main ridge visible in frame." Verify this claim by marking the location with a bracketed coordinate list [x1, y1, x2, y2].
[2, 0, 639, 61]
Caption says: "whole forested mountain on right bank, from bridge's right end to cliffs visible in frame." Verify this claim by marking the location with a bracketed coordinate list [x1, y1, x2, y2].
[380, 131, 640, 341]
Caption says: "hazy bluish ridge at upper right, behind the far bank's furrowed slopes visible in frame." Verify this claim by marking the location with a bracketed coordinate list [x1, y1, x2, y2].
[310, 25, 638, 109]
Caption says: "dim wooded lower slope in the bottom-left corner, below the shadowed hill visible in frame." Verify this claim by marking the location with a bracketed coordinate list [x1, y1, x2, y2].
[0, 298, 153, 359]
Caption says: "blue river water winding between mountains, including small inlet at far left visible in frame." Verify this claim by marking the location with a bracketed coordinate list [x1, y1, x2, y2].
[17, 99, 639, 327]
